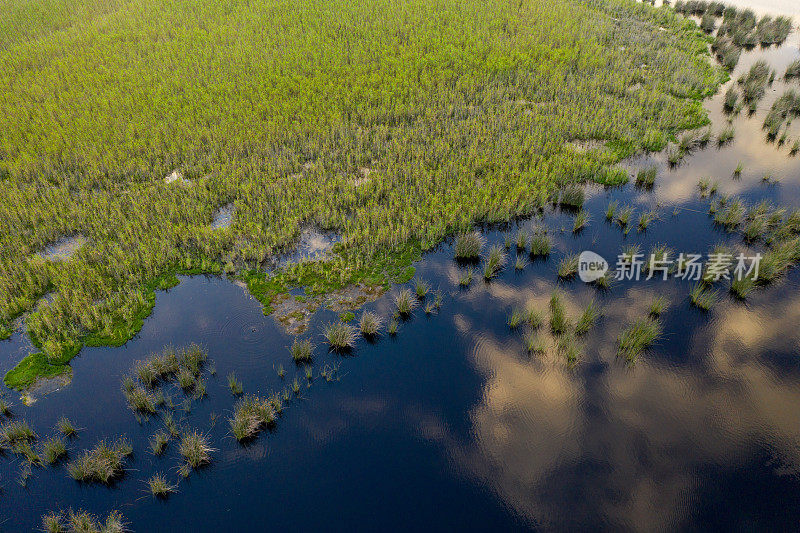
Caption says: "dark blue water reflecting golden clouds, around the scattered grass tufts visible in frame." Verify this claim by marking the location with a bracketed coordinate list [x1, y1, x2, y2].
[0, 9, 800, 531]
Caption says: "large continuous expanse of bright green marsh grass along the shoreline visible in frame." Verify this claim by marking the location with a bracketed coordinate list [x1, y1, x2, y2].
[0, 0, 720, 389]
